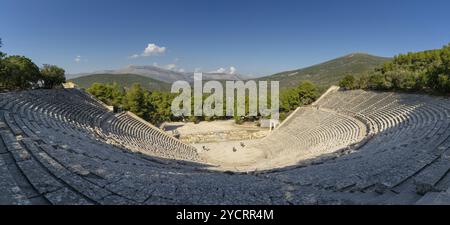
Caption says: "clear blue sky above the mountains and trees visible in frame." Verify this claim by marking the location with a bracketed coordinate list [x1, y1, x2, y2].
[0, 0, 450, 75]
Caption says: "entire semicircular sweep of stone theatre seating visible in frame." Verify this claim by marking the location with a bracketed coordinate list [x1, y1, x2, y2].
[0, 90, 450, 204]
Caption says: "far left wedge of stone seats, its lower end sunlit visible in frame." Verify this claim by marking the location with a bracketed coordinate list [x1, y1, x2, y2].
[1, 90, 199, 163]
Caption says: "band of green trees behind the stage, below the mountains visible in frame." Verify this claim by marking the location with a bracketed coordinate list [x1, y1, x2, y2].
[86, 81, 318, 125]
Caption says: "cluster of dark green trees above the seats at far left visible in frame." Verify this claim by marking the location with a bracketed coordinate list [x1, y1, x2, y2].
[0, 39, 66, 90]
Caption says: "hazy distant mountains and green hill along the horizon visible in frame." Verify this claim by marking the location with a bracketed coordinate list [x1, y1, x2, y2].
[69, 52, 392, 90]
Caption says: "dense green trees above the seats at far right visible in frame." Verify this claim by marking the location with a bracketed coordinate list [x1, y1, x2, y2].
[339, 44, 450, 94]
